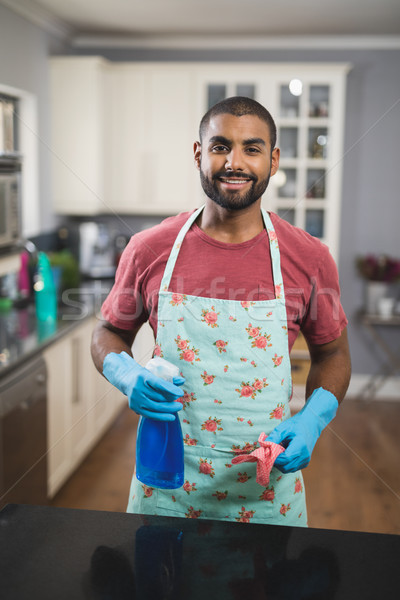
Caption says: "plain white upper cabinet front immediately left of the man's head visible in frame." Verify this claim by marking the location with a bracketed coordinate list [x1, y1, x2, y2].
[110, 63, 199, 215]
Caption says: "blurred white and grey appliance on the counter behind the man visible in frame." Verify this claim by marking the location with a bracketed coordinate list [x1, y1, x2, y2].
[79, 221, 115, 279]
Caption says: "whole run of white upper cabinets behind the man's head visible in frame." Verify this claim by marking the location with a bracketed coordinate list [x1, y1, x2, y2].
[51, 57, 349, 257]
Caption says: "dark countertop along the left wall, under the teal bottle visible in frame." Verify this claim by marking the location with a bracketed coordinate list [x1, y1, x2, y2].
[0, 280, 112, 378]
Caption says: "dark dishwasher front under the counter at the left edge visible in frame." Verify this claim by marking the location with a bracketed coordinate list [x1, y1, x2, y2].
[0, 356, 47, 507]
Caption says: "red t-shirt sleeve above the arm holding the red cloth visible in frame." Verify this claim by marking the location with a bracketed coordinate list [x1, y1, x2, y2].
[300, 246, 347, 344]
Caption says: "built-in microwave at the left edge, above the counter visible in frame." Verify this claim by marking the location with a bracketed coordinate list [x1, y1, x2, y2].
[0, 158, 21, 251]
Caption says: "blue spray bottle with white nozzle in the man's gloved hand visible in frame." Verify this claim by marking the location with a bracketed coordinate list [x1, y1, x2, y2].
[136, 357, 184, 489]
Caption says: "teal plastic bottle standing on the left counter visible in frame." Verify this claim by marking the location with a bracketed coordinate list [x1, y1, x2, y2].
[33, 252, 57, 324]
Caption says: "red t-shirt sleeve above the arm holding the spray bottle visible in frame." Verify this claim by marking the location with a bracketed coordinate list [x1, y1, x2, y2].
[101, 237, 148, 331]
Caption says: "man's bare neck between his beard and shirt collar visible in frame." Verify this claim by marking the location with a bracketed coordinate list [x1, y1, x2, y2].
[197, 198, 264, 244]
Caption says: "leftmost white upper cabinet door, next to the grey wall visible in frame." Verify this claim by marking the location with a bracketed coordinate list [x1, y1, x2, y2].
[50, 57, 111, 215]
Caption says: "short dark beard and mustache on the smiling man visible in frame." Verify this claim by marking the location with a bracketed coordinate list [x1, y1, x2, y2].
[200, 167, 271, 210]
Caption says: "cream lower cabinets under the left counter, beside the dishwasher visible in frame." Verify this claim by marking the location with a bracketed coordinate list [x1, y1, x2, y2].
[43, 317, 126, 497]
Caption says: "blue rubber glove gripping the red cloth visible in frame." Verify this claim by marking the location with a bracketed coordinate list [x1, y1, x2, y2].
[266, 388, 339, 473]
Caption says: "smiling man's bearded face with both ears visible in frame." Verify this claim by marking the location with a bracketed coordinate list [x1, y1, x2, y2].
[194, 114, 279, 210]
